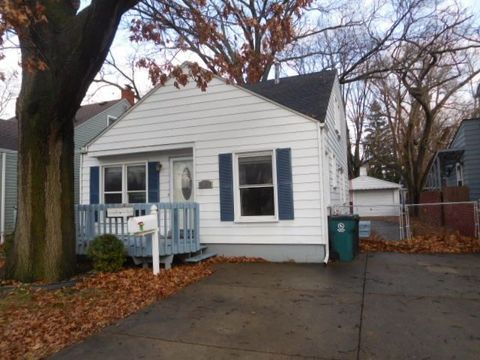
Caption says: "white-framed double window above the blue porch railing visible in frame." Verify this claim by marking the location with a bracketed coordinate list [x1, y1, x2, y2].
[103, 164, 147, 204]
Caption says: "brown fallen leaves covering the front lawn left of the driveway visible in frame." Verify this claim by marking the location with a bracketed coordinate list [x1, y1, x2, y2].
[0, 257, 261, 359]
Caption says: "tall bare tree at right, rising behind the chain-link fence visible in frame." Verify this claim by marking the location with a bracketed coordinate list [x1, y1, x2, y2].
[373, 2, 480, 203]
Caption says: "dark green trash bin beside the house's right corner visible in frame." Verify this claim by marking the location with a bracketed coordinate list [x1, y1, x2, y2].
[328, 215, 360, 261]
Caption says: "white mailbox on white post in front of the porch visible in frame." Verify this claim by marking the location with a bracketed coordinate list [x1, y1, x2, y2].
[128, 205, 160, 275]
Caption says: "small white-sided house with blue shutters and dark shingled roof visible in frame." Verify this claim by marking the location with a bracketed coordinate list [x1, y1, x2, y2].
[78, 71, 348, 262]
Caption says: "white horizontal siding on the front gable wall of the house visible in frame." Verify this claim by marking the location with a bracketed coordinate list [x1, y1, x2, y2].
[82, 79, 326, 248]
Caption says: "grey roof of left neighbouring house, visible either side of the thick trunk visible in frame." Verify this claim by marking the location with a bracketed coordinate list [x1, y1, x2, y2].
[0, 99, 122, 150]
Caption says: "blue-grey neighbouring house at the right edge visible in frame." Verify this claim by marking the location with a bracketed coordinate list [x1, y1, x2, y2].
[425, 118, 480, 201]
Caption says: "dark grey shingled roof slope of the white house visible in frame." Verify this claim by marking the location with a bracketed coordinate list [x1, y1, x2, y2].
[243, 70, 337, 122]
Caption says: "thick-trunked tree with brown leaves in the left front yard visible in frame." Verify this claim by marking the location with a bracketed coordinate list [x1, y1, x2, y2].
[0, 0, 137, 281]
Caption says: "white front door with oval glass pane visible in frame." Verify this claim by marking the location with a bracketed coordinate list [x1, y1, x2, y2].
[172, 158, 195, 202]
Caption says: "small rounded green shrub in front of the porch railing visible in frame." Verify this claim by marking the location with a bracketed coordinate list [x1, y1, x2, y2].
[87, 234, 125, 272]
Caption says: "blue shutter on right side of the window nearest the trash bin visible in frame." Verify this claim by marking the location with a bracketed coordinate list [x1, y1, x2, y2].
[276, 148, 294, 220]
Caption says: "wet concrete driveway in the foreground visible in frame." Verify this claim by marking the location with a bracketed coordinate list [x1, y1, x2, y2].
[55, 254, 480, 360]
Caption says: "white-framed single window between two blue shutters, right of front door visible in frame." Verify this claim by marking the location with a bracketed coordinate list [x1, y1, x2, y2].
[237, 152, 275, 219]
